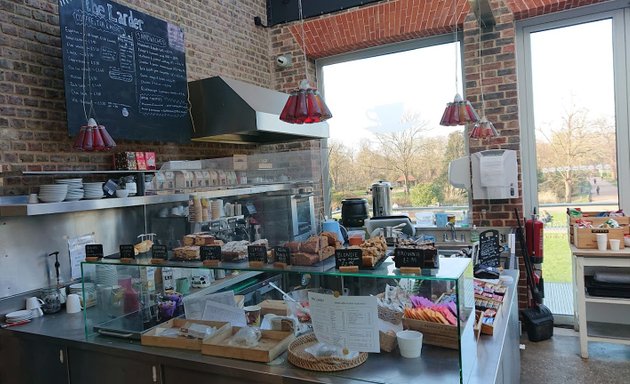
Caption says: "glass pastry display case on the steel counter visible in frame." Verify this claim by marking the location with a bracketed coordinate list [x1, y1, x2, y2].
[81, 252, 477, 383]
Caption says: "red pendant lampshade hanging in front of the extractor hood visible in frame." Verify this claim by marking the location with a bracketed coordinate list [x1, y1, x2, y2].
[280, 79, 332, 124]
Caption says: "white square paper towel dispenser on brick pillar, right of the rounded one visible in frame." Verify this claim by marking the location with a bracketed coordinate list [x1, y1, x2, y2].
[470, 149, 518, 200]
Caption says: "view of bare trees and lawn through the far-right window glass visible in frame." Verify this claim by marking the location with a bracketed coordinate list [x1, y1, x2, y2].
[529, 20, 619, 315]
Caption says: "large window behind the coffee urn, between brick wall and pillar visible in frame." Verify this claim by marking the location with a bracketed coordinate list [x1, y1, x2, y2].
[317, 35, 469, 225]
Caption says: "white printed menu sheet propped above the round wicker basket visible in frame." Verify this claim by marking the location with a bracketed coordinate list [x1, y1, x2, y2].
[308, 292, 380, 352]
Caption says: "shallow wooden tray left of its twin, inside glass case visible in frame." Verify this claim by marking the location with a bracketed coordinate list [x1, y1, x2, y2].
[140, 319, 230, 351]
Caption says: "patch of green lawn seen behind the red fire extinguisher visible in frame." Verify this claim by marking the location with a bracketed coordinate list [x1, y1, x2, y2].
[543, 232, 573, 283]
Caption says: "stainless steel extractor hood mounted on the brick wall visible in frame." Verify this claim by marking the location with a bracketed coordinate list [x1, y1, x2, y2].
[188, 76, 328, 144]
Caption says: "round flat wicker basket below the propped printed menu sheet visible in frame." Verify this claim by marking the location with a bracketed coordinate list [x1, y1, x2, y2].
[287, 333, 368, 372]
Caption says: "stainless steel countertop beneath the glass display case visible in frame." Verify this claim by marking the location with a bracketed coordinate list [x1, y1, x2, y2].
[0, 271, 520, 384]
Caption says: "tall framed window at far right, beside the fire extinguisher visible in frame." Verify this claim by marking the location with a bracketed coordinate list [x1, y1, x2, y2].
[517, 2, 630, 321]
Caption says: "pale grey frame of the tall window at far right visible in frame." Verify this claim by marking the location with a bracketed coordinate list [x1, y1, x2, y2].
[516, 1, 630, 212]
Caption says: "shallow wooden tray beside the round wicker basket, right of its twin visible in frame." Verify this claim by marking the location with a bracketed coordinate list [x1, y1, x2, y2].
[201, 327, 295, 363]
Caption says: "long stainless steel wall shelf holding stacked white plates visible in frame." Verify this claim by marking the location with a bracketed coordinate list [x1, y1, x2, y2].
[0, 184, 292, 217]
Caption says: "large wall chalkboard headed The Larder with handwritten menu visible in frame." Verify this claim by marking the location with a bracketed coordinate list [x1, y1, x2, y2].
[59, 0, 191, 142]
